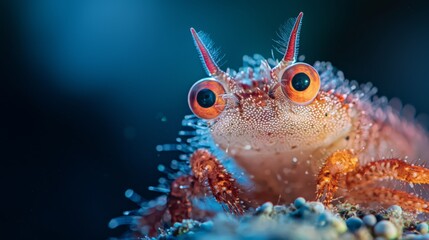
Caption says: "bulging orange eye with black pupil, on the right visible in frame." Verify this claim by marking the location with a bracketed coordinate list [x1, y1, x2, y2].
[281, 63, 320, 105]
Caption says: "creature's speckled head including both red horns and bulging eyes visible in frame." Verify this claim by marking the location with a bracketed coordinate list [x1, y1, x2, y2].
[189, 13, 351, 154]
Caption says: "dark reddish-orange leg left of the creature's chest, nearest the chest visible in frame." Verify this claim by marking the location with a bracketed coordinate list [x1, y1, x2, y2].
[191, 149, 245, 214]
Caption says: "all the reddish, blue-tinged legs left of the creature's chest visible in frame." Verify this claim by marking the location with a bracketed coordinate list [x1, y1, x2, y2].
[109, 149, 244, 239]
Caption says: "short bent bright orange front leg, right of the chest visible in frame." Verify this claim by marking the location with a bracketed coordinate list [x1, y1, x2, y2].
[316, 150, 358, 205]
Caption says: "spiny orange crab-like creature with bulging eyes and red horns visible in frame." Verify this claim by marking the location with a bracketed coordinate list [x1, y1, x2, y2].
[111, 13, 429, 237]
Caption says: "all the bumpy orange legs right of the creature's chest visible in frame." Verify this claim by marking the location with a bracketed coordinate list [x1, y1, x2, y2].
[316, 150, 429, 212]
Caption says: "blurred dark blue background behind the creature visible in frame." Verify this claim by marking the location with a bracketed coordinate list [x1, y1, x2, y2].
[0, 0, 429, 239]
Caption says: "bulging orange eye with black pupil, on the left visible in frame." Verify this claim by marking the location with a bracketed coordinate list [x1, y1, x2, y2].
[188, 78, 226, 119]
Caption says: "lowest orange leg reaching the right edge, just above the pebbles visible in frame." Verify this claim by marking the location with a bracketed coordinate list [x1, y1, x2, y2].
[347, 187, 429, 213]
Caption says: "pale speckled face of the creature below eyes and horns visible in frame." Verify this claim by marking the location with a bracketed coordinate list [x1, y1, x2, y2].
[209, 73, 351, 155]
